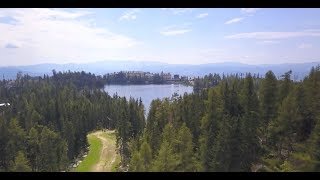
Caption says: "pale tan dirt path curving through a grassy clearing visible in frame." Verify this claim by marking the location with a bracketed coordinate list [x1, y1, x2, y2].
[92, 131, 117, 172]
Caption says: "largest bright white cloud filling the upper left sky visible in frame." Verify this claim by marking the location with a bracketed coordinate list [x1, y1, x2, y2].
[0, 9, 140, 63]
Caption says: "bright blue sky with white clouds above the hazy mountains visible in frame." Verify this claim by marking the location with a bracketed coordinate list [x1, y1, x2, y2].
[0, 8, 320, 66]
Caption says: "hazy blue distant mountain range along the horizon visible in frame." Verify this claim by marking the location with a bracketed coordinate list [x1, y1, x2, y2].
[0, 61, 320, 80]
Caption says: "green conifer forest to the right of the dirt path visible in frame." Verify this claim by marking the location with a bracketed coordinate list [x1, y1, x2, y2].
[127, 66, 320, 171]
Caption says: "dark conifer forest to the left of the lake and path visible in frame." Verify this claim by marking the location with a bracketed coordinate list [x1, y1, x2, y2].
[0, 71, 144, 171]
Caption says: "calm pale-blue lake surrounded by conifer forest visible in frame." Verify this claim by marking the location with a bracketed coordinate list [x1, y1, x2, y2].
[104, 84, 193, 115]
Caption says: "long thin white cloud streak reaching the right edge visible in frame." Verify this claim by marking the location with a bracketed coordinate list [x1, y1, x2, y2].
[225, 29, 320, 40]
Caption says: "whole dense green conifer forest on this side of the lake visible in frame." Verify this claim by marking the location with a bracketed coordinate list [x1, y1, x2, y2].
[0, 66, 320, 172]
